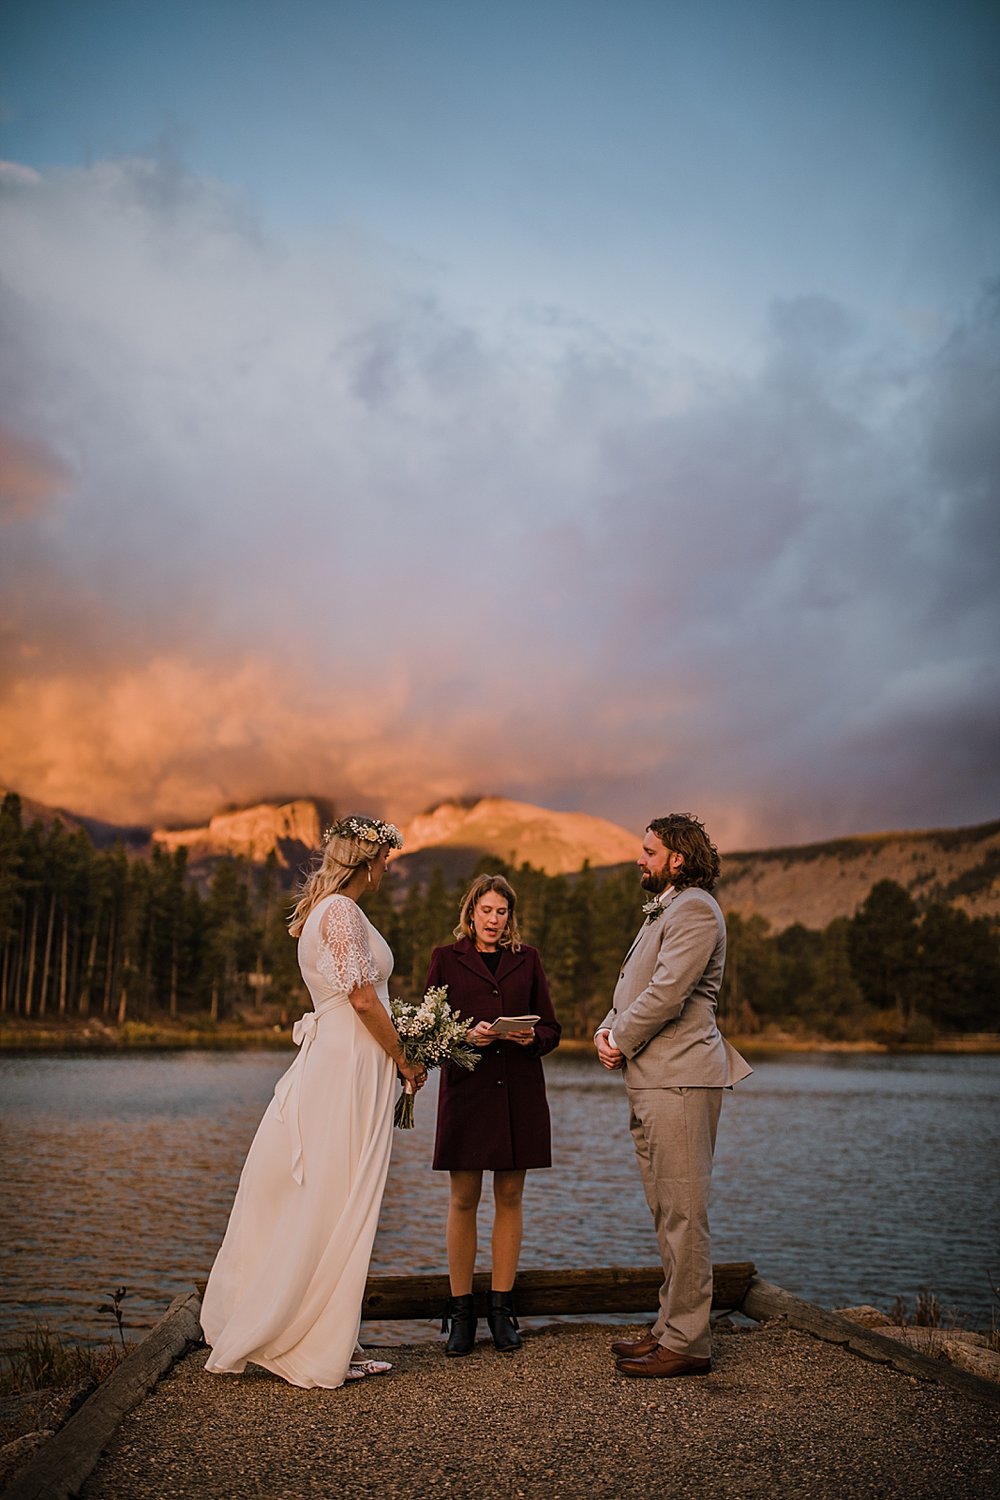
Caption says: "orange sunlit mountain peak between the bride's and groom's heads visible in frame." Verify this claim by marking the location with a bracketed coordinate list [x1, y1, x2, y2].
[403, 797, 642, 875]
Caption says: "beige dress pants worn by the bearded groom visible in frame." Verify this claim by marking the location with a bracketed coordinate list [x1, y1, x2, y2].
[627, 1089, 723, 1359]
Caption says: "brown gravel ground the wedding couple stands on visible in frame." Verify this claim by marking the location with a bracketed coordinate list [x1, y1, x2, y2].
[82, 1322, 1000, 1500]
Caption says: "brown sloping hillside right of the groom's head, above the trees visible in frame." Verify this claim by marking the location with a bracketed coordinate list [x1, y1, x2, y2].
[717, 822, 1000, 932]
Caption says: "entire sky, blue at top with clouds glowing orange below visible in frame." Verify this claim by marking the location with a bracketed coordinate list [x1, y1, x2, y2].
[0, 0, 1000, 849]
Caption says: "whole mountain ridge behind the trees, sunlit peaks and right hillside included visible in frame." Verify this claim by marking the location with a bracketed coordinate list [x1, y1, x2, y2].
[3, 797, 1000, 932]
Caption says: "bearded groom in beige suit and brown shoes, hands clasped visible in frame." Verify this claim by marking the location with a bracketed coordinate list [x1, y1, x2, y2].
[594, 813, 751, 1379]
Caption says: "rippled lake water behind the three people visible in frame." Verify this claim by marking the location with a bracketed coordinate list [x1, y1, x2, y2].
[0, 1052, 1000, 1337]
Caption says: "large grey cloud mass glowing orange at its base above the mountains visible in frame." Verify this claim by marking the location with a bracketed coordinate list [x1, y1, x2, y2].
[0, 161, 1000, 848]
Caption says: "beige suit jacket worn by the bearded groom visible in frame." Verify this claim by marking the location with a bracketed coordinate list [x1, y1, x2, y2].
[597, 887, 753, 1089]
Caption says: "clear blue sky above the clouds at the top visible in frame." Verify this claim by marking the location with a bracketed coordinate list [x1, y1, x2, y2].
[4, 0, 1000, 354]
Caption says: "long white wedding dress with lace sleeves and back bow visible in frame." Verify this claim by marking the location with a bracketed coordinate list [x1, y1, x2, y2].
[201, 896, 396, 1386]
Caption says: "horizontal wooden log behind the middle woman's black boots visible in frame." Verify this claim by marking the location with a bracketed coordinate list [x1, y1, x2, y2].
[361, 1260, 754, 1322]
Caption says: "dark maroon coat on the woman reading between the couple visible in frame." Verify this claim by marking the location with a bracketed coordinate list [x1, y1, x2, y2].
[426, 938, 562, 1172]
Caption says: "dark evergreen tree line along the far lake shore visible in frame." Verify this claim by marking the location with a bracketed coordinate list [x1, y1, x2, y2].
[0, 794, 1000, 1044]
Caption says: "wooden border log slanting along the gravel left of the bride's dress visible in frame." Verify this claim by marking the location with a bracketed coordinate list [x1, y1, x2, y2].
[3, 1292, 201, 1500]
